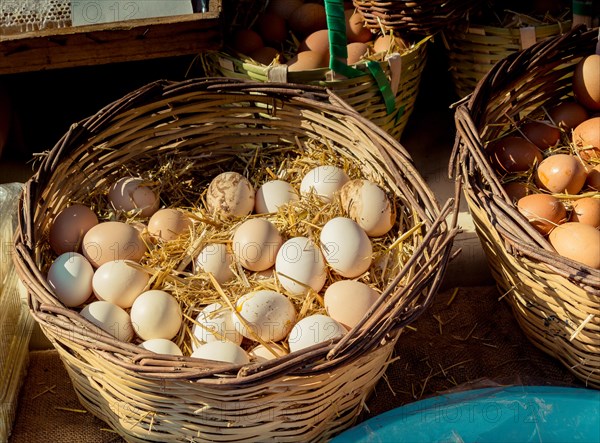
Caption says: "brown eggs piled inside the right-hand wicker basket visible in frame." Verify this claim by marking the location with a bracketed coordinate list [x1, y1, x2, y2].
[488, 54, 600, 269]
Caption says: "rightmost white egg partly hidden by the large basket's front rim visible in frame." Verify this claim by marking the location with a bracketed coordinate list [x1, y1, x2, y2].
[288, 314, 348, 352]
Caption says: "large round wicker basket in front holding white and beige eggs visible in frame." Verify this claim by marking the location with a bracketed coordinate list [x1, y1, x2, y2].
[15, 78, 456, 442]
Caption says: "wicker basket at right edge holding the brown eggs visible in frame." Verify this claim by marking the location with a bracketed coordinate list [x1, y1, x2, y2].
[450, 27, 600, 388]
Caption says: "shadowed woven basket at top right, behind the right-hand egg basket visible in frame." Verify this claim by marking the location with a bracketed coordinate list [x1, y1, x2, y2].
[442, 15, 571, 97]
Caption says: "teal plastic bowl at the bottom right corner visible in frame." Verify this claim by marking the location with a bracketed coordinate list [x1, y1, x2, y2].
[331, 386, 600, 443]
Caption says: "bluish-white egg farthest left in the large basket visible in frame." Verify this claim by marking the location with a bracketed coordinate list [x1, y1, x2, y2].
[48, 252, 94, 307]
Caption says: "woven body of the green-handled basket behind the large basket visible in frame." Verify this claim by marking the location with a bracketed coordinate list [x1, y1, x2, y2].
[202, 1, 429, 139]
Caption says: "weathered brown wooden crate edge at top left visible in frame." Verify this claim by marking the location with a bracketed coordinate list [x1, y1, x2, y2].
[0, 0, 223, 74]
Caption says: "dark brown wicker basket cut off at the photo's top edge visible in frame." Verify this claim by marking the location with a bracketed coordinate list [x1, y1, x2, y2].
[352, 0, 482, 35]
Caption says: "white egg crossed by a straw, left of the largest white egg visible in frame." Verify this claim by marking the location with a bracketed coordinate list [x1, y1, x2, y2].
[275, 237, 327, 295]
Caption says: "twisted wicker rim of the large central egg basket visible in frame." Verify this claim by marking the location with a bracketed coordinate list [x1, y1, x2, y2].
[14, 78, 458, 386]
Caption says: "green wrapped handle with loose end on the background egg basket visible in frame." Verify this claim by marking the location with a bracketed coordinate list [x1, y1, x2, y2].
[325, 0, 396, 115]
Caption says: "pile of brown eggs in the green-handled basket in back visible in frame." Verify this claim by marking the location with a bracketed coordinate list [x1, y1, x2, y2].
[229, 0, 409, 71]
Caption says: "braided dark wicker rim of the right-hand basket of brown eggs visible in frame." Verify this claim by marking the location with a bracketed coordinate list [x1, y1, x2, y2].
[449, 25, 600, 310]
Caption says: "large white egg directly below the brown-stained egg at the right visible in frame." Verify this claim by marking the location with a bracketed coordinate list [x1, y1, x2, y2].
[320, 217, 373, 278]
